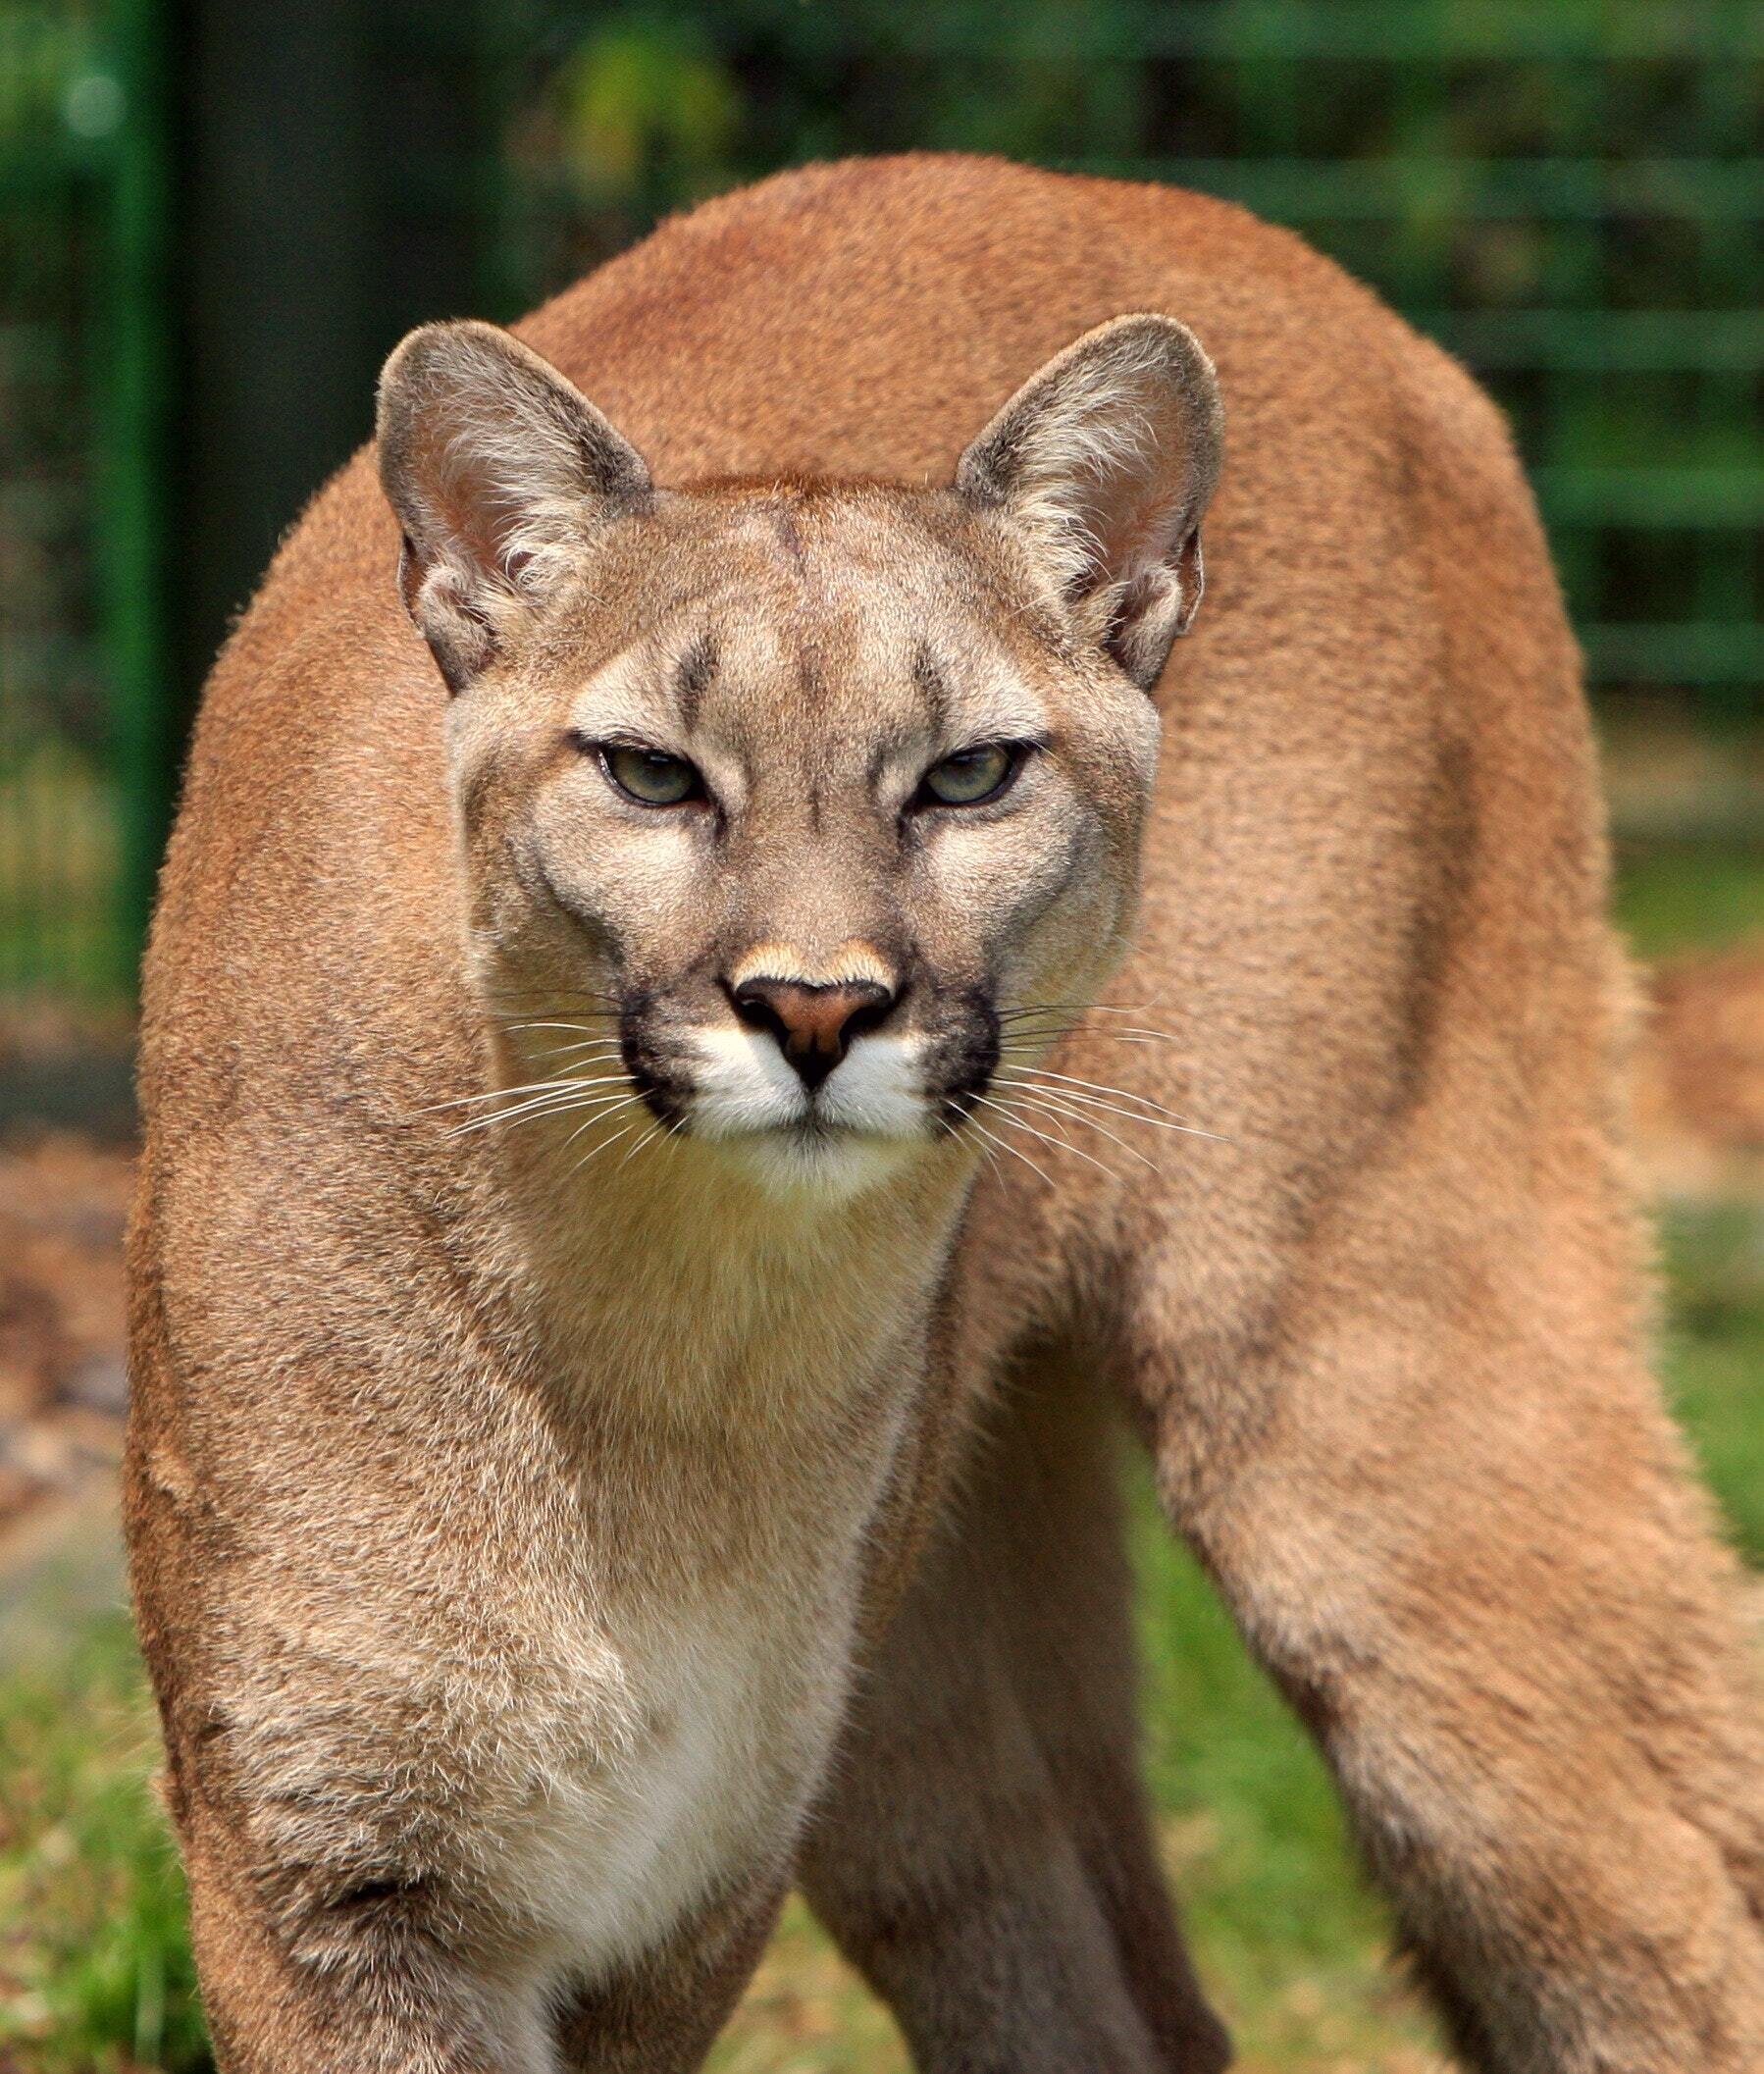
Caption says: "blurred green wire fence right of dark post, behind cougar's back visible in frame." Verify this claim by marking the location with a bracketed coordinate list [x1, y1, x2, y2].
[489, 0, 1764, 722]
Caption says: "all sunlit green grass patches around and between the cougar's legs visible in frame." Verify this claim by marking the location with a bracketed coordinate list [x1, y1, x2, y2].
[0, 853, 1764, 2074]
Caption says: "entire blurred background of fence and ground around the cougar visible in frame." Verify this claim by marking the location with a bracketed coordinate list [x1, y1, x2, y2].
[0, 0, 1764, 2074]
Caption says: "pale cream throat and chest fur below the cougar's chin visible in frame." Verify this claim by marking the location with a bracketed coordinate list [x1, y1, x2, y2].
[481, 1144, 956, 1999]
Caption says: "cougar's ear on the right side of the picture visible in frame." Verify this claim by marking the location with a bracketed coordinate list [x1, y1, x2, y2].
[956, 315, 1225, 691]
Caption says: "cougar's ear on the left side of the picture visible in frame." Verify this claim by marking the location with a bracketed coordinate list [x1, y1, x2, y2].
[375, 324, 650, 691]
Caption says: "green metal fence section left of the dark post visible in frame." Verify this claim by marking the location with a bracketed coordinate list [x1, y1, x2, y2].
[0, 4, 174, 994]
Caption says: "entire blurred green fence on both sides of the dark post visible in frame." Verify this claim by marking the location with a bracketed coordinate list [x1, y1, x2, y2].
[0, 0, 1764, 991]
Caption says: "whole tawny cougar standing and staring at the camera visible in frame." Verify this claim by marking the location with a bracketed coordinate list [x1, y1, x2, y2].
[127, 158, 1764, 2074]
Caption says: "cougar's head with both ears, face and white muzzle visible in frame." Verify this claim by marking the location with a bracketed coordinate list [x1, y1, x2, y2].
[380, 315, 1220, 1188]
